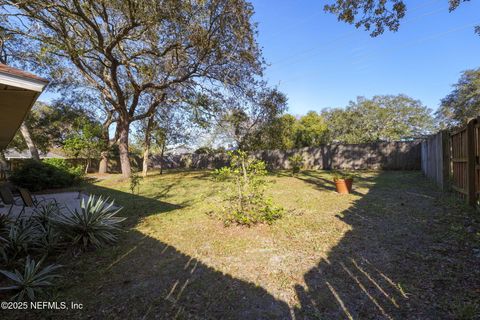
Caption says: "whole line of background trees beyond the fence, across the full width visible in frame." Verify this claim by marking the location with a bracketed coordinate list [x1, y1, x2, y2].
[10, 69, 480, 168]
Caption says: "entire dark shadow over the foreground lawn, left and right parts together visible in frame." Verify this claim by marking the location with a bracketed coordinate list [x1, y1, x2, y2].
[42, 173, 478, 320]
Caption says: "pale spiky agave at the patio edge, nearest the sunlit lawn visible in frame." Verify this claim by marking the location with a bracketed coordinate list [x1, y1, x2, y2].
[54, 195, 125, 249]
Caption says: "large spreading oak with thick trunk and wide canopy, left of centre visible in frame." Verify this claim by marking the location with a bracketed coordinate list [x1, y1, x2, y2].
[0, 0, 263, 177]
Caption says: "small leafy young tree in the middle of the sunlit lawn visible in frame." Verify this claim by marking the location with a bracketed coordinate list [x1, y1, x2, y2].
[215, 151, 283, 225]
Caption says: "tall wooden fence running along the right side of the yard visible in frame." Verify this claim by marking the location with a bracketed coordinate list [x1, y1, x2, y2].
[422, 117, 480, 206]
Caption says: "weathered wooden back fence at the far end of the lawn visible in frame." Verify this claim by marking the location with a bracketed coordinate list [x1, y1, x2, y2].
[151, 141, 421, 170]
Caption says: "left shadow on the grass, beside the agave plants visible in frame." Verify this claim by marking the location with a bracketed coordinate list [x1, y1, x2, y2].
[41, 181, 290, 319]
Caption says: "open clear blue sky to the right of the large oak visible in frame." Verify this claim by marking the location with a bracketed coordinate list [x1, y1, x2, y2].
[253, 0, 480, 114]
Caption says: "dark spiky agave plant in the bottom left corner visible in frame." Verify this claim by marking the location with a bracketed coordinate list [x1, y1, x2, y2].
[0, 256, 61, 301]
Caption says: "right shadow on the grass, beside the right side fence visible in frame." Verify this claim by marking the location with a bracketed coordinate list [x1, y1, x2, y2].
[295, 172, 480, 320]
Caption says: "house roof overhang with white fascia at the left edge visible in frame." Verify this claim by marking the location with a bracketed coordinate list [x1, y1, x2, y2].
[0, 64, 48, 150]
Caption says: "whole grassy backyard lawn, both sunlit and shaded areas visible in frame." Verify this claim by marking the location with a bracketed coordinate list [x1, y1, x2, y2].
[18, 171, 480, 319]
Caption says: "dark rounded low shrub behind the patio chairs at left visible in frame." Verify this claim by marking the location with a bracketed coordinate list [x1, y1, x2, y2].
[10, 159, 83, 191]
